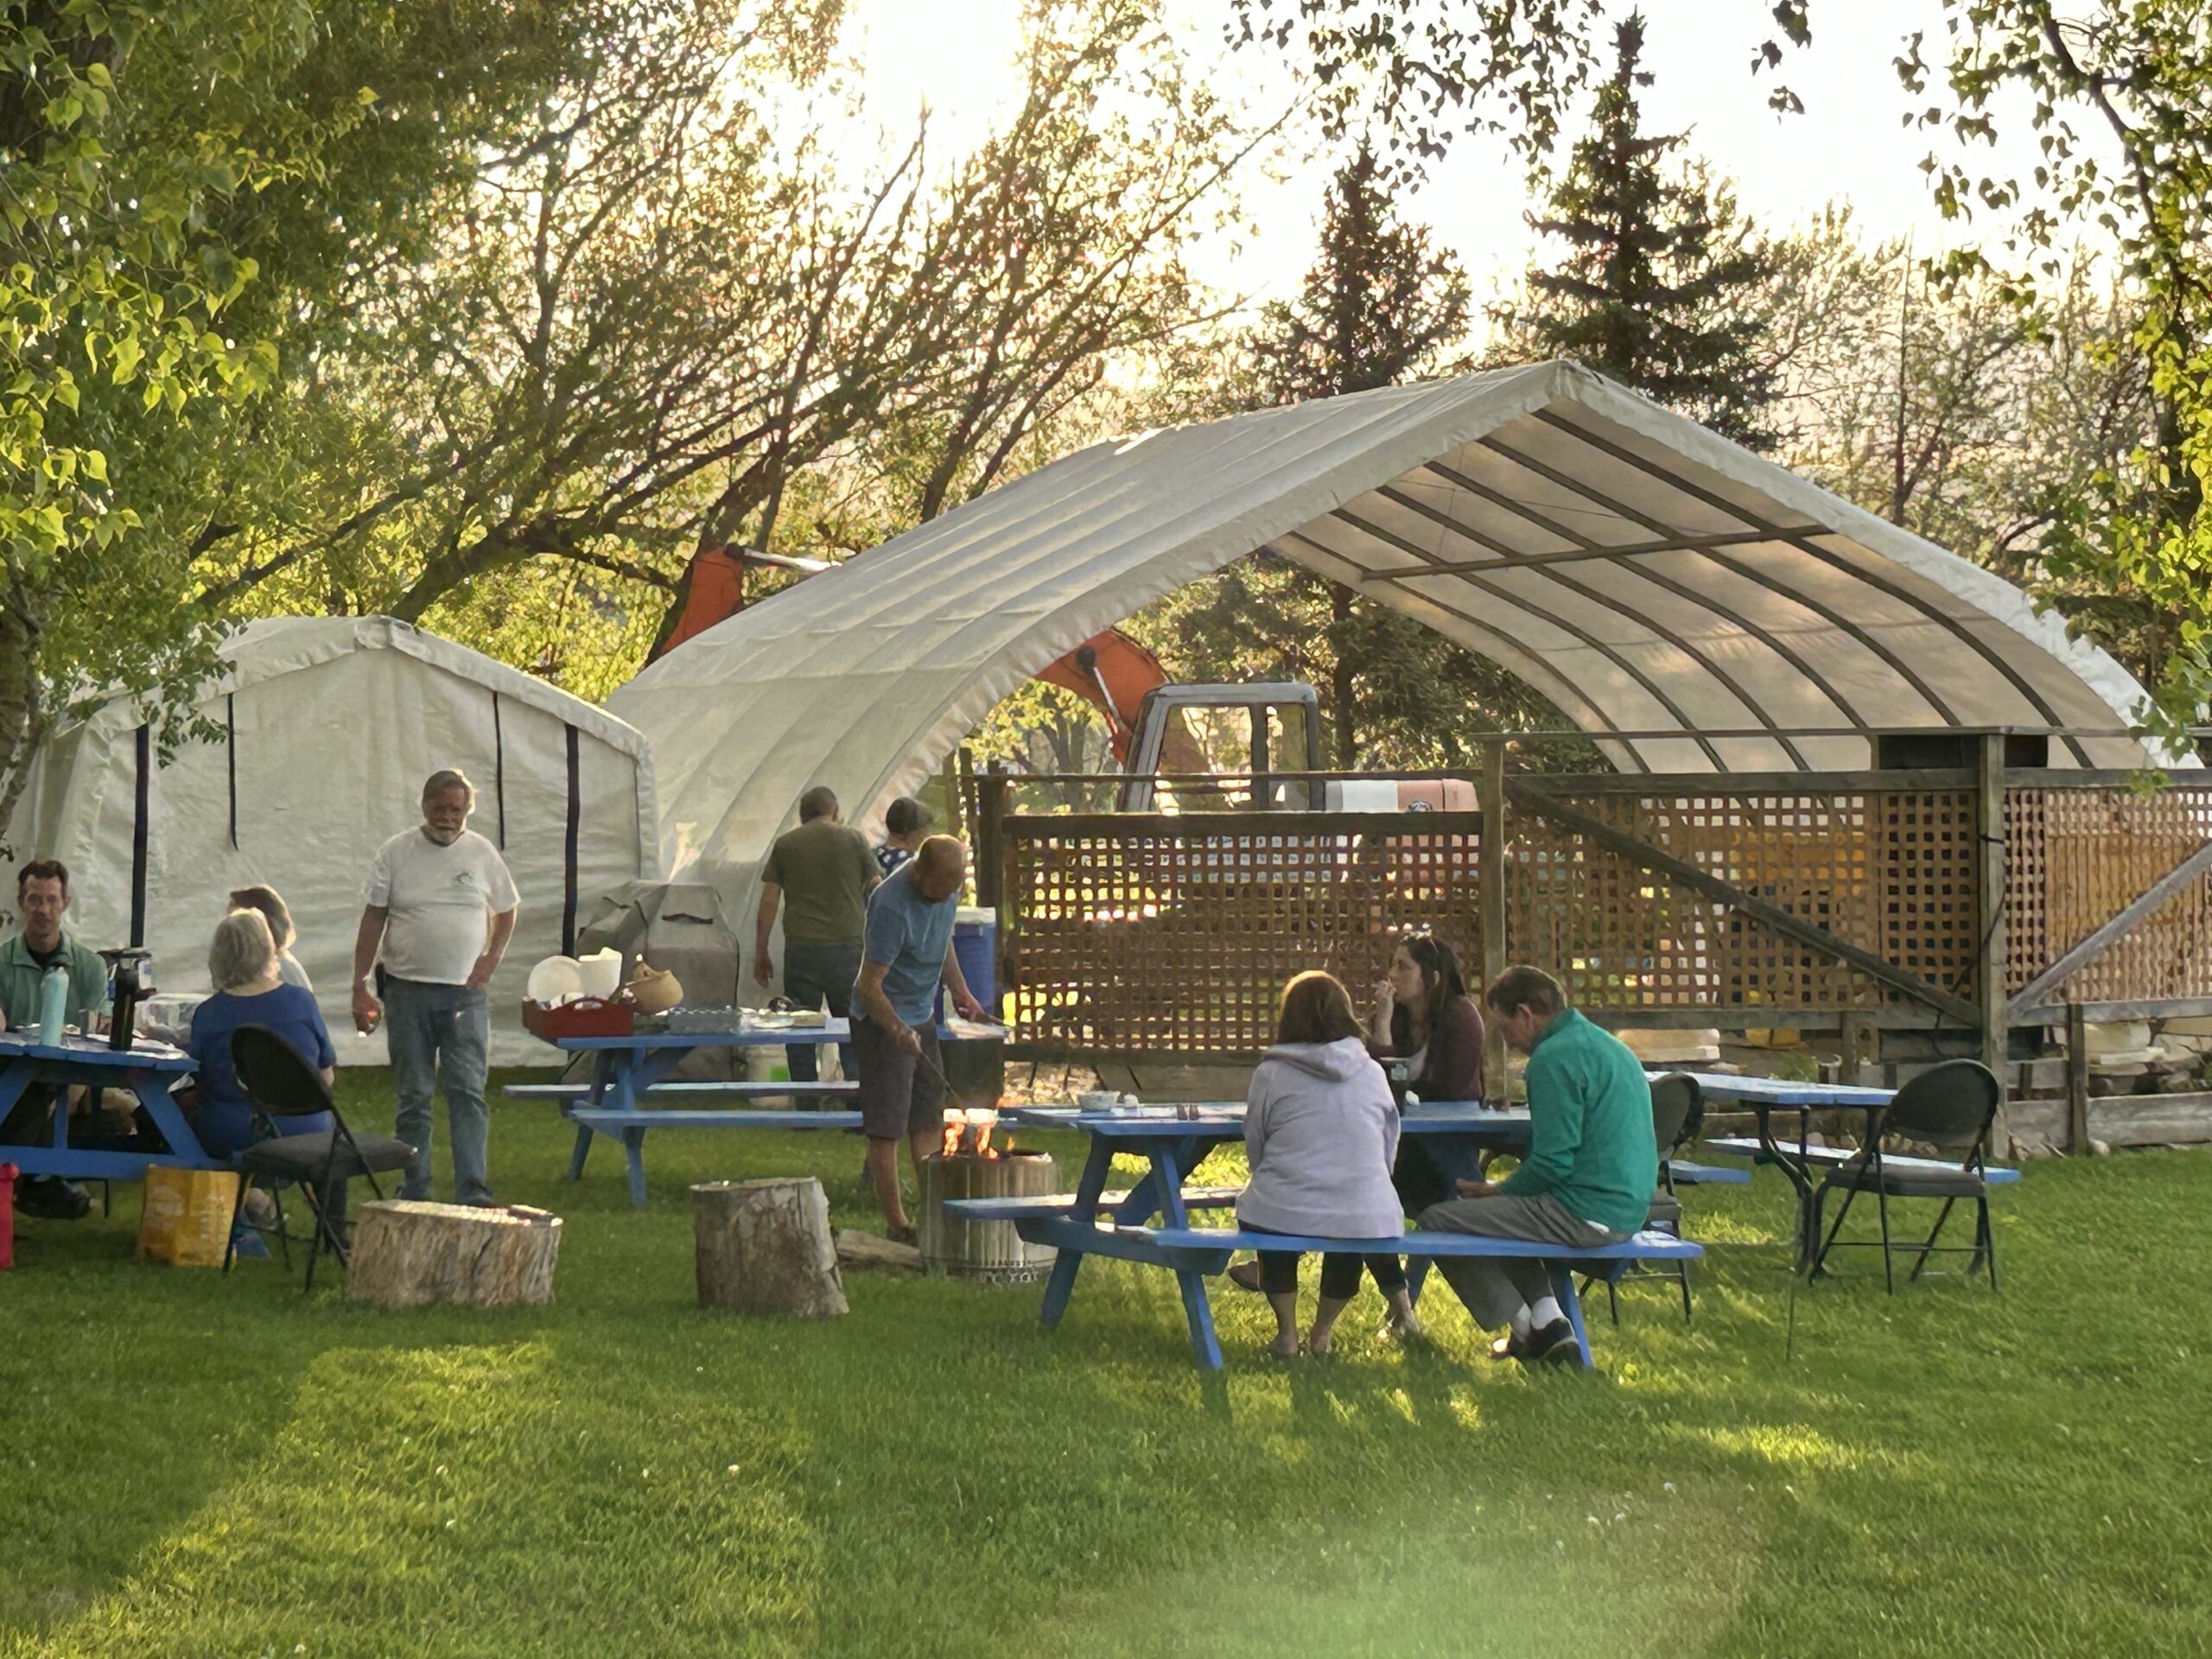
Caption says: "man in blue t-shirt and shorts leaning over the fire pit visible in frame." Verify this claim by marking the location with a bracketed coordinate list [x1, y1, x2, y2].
[852, 836, 982, 1243]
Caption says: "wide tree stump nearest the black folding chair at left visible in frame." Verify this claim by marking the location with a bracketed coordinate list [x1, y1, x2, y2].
[345, 1199, 560, 1307]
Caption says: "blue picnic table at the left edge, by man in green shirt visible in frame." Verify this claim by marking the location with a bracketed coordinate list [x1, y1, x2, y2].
[0, 1031, 214, 1181]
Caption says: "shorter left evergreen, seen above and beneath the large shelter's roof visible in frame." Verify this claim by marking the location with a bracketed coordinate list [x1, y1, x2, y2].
[1139, 146, 1557, 770]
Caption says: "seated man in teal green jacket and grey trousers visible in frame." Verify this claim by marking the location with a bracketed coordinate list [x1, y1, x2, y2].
[1418, 967, 1659, 1360]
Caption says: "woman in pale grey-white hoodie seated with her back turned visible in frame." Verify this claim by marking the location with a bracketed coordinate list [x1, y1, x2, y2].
[1236, 973, 1421, 1358]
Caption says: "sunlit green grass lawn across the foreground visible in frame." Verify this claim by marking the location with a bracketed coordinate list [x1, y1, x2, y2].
[0, 1073, 2212, 1659]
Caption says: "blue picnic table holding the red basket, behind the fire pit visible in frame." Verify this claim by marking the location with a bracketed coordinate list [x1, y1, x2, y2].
[553, 1018, 1000, 1210]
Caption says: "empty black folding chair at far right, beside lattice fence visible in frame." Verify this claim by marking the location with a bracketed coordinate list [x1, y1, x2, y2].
[1812, 1059, 2002, 1296]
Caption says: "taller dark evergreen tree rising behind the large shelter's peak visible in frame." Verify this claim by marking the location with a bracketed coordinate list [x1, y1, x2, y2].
[1496, 13, 1778, 449]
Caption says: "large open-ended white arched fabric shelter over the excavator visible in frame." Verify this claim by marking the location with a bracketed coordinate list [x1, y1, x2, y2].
[608, 363, 2188, 916]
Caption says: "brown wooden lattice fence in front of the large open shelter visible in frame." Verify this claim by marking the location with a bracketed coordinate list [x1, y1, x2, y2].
[1000, 772, 2212, 1055]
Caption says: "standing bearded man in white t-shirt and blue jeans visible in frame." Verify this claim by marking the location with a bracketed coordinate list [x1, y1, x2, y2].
[354, 772, 520, 1204]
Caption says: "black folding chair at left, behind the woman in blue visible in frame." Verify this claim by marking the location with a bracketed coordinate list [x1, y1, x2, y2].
[224, 1027, 414, 1289]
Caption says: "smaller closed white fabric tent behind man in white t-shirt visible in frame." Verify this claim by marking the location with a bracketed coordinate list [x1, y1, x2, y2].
[0, 617, 659, 1064]
